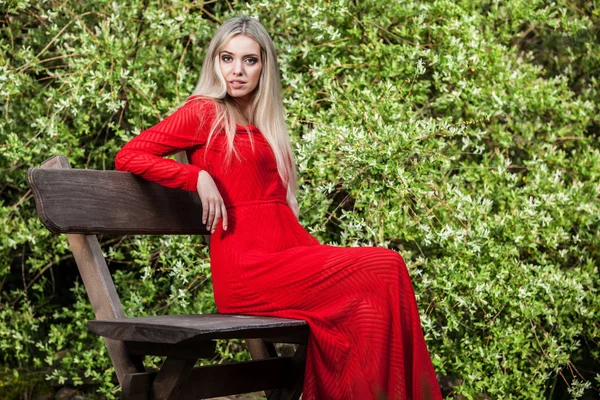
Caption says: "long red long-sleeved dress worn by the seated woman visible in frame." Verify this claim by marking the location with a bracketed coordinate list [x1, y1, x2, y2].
[116, 96, 441, 400]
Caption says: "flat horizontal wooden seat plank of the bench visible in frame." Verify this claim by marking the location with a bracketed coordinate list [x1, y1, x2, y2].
[87, 314, 309, 344]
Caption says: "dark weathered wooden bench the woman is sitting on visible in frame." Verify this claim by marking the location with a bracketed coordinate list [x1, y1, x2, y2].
[27, 156, 309, 400]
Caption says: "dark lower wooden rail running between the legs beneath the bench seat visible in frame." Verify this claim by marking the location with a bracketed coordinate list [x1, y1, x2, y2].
[123, 357, 291, 400]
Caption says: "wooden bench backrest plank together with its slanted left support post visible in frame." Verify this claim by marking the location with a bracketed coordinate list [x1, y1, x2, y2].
[27, 156, 209, 384]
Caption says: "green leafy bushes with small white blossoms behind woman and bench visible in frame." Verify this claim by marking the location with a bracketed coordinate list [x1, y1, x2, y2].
[0, 0, 600, 399]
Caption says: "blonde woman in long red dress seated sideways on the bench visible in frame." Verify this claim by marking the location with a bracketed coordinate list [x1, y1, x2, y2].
[116, 17, 441, 400]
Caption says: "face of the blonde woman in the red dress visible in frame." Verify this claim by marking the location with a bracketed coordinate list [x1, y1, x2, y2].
[219, 35, 262, 101]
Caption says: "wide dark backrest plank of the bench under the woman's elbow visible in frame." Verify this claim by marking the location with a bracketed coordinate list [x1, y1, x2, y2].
[27, 168, 210, 235]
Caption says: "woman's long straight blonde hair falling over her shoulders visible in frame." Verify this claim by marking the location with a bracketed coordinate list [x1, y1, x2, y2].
[192, 17, 297, 194]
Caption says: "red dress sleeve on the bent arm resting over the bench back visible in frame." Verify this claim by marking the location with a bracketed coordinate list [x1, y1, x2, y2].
[115, 99, 214, 192]
